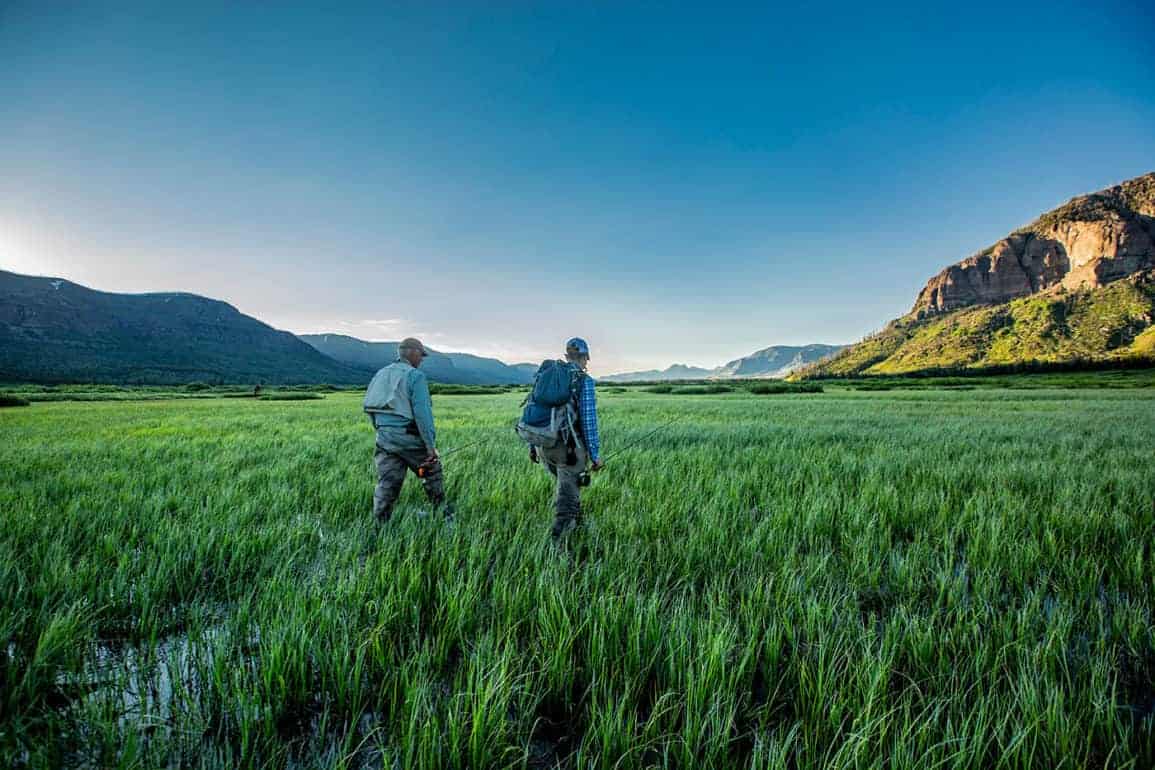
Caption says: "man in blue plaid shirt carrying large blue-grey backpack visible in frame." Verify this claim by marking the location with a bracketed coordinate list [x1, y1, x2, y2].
[517, 337, 602, 540]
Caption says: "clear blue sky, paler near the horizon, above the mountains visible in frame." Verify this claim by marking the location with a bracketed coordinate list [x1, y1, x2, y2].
[0, 0, 1155, 373]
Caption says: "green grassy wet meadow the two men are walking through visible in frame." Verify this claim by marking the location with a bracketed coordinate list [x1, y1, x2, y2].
[0, 383, 1155, 770]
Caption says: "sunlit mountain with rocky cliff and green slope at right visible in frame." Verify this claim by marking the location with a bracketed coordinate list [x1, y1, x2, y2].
[802, 173, 1155, 376]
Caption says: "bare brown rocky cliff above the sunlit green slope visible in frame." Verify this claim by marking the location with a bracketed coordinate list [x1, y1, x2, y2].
[911, 173, 1155, 317]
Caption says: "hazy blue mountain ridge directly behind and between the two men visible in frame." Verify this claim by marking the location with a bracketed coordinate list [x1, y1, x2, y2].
[299, 334, 537, 384]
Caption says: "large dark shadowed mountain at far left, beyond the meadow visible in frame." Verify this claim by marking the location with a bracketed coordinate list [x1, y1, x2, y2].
[0, 270, 368, 384]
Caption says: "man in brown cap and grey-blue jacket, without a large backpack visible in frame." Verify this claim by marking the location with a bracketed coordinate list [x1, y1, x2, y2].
[365, 337, 453, 522]
